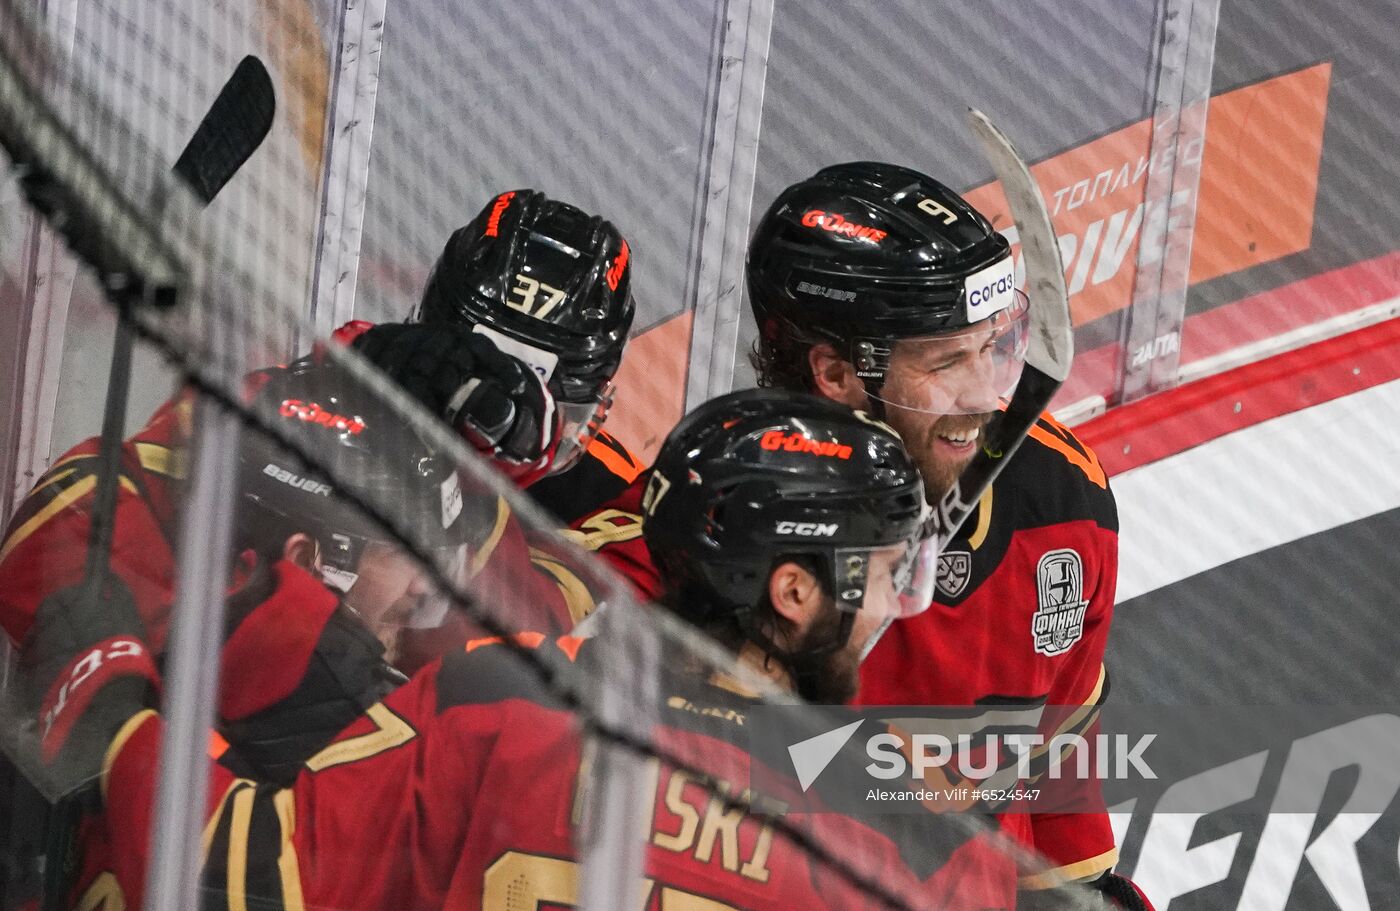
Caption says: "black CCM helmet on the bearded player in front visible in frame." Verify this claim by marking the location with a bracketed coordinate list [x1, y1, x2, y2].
[643, 389, 937, 660]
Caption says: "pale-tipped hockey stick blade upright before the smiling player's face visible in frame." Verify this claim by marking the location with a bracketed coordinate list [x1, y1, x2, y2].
[928, 108, 1074, 550]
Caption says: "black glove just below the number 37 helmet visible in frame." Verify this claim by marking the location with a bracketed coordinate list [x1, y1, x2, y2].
[351, 323, 560, 487]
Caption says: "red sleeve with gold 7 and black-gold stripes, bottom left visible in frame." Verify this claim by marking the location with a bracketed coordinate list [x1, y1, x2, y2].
[101, 652, 526, 911]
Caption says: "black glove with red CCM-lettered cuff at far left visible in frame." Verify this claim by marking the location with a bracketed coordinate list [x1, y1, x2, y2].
[20, 575, 160, 792]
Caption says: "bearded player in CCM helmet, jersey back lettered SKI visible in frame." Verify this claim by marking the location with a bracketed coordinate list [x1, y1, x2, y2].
[34, 390, 1024, 911]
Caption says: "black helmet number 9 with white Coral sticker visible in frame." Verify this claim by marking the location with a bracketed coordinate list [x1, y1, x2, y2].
[748, 161, 1026, 413]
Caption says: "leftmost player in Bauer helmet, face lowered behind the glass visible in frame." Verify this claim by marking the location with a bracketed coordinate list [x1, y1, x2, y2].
[20, 361, 509, 897]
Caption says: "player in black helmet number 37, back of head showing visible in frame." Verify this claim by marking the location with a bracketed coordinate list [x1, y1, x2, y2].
[0, 190, 638, 669]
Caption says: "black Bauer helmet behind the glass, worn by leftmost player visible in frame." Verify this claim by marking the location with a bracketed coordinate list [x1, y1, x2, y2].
[235, 358, 493, 592]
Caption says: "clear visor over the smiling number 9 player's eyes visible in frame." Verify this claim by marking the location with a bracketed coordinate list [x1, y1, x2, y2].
[871, 291, 1030, 414]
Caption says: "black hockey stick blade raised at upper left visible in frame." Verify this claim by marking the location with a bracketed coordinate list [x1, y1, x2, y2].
[175, 56, 277, 206]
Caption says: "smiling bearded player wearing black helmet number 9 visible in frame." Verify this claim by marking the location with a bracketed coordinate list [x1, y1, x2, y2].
[748, 162, 1141, 907]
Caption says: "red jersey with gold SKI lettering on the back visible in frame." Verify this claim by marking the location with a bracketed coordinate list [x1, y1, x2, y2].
[95, 635, 1007, 911]
